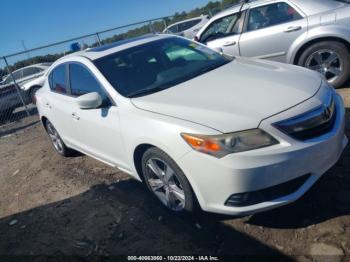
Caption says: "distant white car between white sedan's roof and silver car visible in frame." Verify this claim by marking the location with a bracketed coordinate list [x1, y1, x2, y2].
[163, 15, 209, 39]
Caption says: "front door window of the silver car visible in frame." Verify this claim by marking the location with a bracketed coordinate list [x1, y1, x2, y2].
[200, 14, 241, 43]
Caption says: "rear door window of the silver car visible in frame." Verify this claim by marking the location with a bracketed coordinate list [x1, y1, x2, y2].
[247, 2, 302, 31]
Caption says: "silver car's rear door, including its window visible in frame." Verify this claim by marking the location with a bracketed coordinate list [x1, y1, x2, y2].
[239, 1, 308, 63]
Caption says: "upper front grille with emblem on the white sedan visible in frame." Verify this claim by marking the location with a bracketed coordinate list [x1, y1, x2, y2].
[274, 92, 337, 141]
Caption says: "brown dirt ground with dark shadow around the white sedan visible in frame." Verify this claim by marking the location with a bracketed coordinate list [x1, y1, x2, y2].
[0, 89, 350, 261]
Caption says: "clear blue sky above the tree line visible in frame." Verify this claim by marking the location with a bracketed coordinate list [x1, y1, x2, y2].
[0, 0, 209, 56]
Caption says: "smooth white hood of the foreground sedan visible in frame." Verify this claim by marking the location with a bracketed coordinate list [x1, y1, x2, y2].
[131, 58, 322, 133]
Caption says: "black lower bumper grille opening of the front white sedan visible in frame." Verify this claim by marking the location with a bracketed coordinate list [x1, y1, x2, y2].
[225, 174, 311, 207]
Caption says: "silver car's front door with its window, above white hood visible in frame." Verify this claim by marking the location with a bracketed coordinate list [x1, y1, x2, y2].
[199, 12, 244, 55]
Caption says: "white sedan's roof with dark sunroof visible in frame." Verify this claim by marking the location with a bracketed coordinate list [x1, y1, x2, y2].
[75, 34, 172, 60]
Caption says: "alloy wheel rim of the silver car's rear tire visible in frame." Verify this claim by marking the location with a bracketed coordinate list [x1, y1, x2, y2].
[305, 49, 343, 82]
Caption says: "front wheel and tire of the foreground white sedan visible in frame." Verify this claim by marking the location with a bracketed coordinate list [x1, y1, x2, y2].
[142, 147, 196, 213]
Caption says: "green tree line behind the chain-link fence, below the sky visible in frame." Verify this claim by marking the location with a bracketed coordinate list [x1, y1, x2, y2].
[0, 0, 239, 78]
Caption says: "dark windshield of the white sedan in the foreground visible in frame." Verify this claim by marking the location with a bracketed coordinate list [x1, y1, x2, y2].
[95, 37, 230, 97]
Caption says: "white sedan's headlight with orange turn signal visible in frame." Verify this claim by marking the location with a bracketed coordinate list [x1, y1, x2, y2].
[181, 129, 278, 158]
